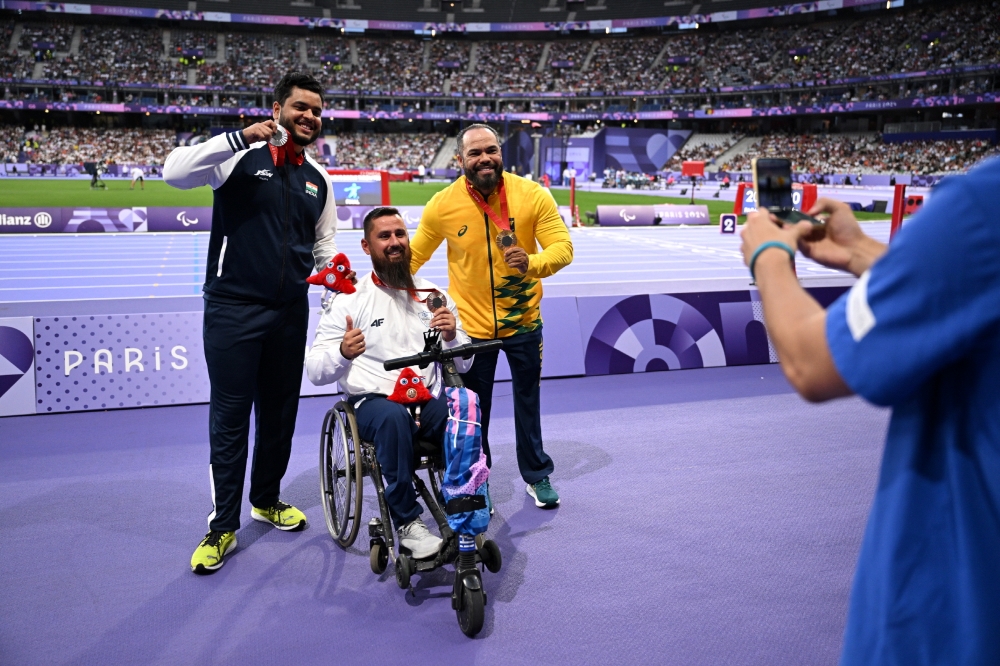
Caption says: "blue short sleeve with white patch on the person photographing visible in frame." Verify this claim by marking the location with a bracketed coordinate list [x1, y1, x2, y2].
[826, 159, 1000, 405]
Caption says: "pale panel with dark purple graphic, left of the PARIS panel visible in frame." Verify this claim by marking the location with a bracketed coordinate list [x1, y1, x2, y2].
[0, 317, 35, 416]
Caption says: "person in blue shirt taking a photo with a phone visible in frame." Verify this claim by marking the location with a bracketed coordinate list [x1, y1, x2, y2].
[742, 158, 1000, 666]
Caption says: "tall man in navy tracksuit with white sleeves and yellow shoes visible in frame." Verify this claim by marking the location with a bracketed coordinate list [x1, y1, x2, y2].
[163, 74, 337, 574]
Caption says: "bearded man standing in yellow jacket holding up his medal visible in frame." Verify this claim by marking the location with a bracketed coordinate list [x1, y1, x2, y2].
[410, 125, 573, 509]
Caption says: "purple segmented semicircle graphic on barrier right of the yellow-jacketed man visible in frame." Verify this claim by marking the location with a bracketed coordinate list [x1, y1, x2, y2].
[584, 294, 726, 375]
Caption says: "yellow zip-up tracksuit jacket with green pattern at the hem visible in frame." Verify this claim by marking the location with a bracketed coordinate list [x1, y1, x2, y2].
[410, 173, 573, 339]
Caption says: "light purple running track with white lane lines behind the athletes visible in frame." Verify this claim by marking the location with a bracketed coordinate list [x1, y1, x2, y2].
[0, 222, 889, 303]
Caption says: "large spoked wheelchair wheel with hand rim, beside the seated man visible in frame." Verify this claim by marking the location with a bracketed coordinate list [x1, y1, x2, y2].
[319, 402, 362, 548]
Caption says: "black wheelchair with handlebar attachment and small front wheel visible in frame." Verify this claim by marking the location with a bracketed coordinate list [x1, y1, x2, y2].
[319, 331, 502, 638]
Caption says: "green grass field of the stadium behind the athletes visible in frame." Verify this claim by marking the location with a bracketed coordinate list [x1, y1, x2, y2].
[0, 178, 886, 222]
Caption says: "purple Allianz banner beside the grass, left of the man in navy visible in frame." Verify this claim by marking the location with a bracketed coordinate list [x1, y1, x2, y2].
[0, 206, 212, 234]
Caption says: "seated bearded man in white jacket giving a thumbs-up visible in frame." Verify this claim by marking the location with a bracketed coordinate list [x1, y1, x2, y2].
[306, 207, 472, 559]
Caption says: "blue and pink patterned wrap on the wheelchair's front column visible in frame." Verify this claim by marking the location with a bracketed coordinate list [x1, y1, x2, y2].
[441, 386, 490, 536]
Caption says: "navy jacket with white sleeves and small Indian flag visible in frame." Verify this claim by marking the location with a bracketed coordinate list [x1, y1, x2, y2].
[163, 131, 337, 305]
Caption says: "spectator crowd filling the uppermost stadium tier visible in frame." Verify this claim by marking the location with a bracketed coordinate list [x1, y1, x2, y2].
[0, 0, 1000, 94]
